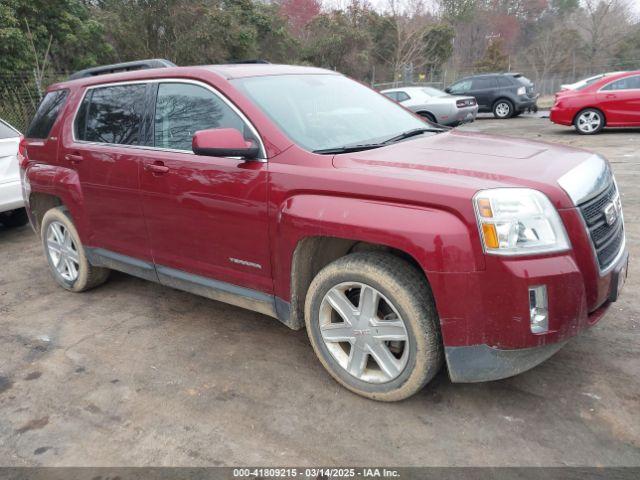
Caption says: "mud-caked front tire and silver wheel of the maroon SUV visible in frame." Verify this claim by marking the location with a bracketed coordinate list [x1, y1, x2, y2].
[305, 252, 443, 401]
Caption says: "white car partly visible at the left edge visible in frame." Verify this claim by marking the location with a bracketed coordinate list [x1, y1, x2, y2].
[0, 120, 28, 227]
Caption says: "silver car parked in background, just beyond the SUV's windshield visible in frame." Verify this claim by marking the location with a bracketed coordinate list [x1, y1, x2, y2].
[380, 87, 478, 126]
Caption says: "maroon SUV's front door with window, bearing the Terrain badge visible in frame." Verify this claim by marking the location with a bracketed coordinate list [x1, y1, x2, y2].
[141, 81, 273, 293]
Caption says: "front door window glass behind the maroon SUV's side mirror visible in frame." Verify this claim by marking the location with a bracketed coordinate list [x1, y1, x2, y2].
[154, 83, 257, 151]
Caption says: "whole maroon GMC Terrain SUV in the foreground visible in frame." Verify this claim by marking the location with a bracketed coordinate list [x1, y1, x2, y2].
[20, 64, 628, 401]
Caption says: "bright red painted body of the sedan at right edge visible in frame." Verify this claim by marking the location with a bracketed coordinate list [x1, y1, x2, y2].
[549, 70, 640, 127]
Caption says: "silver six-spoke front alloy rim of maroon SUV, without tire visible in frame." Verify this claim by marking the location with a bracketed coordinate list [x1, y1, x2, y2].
[319, 282, 410, 383]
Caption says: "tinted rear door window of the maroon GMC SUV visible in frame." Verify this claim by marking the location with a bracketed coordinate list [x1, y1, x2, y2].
[74, 84, 147, 145]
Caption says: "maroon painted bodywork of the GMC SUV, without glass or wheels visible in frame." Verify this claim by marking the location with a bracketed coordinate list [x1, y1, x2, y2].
[23, 65, 624, 348]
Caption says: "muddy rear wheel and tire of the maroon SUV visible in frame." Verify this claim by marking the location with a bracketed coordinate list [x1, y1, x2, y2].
[40, 207, 109, 292]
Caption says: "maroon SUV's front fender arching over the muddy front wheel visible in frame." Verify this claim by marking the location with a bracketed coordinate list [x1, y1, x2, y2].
[273, 195, 484, 328]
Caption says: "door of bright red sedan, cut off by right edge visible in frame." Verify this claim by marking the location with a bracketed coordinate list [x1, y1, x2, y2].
[596, 75, 640, 126]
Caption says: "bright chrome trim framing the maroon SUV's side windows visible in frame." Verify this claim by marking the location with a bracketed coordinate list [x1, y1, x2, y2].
[71, 78, 267, 162]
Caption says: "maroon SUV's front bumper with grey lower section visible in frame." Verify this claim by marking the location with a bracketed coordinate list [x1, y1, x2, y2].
[430, 240, 629, 382]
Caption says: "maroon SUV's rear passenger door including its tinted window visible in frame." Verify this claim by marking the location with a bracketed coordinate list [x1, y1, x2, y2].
[61, 82, 155, 262]
